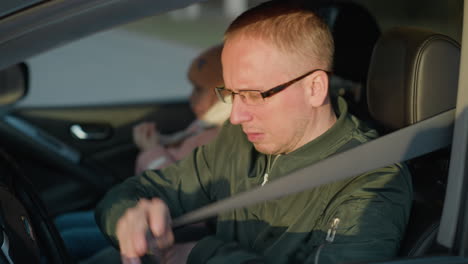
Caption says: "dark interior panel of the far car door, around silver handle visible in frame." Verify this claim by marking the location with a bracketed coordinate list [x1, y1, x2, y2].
[1, 101, 194, 214]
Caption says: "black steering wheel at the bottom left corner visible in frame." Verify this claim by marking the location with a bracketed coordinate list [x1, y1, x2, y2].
[0, 149, 73, 264]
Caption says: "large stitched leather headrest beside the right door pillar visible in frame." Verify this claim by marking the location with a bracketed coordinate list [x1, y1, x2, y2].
[367, 28, 460, 131]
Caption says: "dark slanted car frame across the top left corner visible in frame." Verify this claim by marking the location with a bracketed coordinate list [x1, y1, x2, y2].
[0, 0, 200, 69]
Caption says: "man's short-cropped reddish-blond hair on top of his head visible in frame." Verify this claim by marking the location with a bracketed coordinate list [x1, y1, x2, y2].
[224, 1, 334, 71]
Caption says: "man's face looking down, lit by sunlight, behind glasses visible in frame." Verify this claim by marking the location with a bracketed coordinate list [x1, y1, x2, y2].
[222, 37, 316, 154]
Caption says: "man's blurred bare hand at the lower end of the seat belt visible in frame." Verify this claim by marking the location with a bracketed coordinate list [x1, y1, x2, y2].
[116, 198, 175, 259]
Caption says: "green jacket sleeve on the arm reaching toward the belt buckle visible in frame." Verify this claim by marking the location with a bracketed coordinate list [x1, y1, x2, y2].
[95, 140, 221, 246]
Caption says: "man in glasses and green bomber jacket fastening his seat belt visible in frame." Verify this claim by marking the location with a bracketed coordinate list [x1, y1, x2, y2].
[96, 2, 412, 263]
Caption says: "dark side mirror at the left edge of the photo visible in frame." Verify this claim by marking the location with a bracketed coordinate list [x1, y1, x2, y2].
[0, 63, 29, 107]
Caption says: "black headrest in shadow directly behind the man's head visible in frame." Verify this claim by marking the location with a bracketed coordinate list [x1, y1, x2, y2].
[304, 0, 380, 120]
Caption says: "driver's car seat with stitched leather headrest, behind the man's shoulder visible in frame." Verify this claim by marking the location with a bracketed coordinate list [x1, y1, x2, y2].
[367, 27, 460, 256]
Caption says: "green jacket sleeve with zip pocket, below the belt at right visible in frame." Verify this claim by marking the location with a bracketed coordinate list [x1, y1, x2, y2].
[304, 164, 412, 264]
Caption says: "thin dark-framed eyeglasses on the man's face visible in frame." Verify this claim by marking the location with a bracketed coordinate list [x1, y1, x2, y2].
[215, 69, 329, 105]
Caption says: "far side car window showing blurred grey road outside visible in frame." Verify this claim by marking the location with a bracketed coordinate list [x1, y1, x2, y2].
[19, 1, 238, 106]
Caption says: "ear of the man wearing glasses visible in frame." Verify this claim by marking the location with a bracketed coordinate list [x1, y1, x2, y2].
[305, 71, 328, 107]
